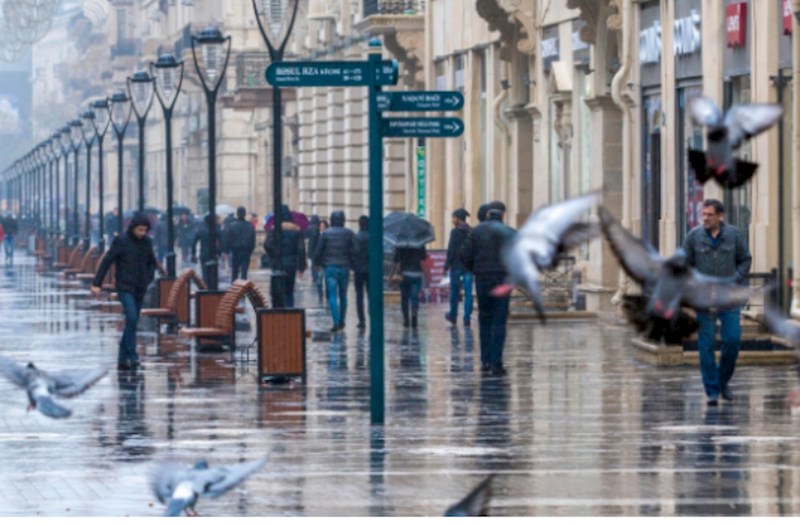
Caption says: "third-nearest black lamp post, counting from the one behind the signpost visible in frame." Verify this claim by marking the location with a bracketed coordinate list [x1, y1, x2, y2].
[150, 54, 183, 278]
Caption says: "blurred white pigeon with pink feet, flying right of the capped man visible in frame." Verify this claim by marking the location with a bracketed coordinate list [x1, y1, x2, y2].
[492, 193, 600, 321]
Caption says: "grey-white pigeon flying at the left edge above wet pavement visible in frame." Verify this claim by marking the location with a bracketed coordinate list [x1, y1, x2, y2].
[0, 357, 108, 419]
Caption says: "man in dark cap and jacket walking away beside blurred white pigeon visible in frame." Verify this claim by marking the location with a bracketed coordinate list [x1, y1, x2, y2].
[459, 201, 515, 375]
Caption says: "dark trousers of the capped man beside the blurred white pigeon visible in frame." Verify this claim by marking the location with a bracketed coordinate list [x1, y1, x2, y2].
[475, 275, 511, 368]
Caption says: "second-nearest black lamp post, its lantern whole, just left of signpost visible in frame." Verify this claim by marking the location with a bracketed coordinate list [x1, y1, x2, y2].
[192, 27, 231, 290]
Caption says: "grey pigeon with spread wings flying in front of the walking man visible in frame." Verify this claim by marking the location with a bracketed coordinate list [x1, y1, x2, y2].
[599, 206, 750, 342]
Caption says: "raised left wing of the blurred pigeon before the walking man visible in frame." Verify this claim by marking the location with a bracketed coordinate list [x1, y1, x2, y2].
[599, 206, 663, 284]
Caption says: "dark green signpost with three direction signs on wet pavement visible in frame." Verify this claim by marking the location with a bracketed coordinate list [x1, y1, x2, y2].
[265, 39, 464, 425]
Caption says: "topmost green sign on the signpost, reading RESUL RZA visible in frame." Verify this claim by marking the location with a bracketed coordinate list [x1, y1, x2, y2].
[266, 60, 399, 87]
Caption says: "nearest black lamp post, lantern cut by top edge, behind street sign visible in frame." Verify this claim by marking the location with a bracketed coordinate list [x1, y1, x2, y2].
[253, 0, 299, 308]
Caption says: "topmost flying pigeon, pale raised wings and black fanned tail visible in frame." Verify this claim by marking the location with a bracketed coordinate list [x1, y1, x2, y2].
[689, 97, 783, 189]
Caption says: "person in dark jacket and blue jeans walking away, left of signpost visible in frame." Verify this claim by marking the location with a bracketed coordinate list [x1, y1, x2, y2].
[314, 210, 355, 332]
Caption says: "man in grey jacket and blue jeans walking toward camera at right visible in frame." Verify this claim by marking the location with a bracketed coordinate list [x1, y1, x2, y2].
[683, 199, 752, 406]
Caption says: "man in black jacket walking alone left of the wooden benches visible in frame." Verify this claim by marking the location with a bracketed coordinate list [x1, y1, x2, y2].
[92, 214, 157, 370]
